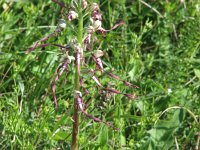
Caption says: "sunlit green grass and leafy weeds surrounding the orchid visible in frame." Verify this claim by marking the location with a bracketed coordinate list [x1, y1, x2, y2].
[0, 0, 200, 150]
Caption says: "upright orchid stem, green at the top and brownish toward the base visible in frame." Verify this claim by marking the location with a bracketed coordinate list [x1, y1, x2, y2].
[71, 0, 83, 150]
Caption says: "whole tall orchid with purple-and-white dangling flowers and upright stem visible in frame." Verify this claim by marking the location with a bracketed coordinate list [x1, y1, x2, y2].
[26, 0, 138, 149]
